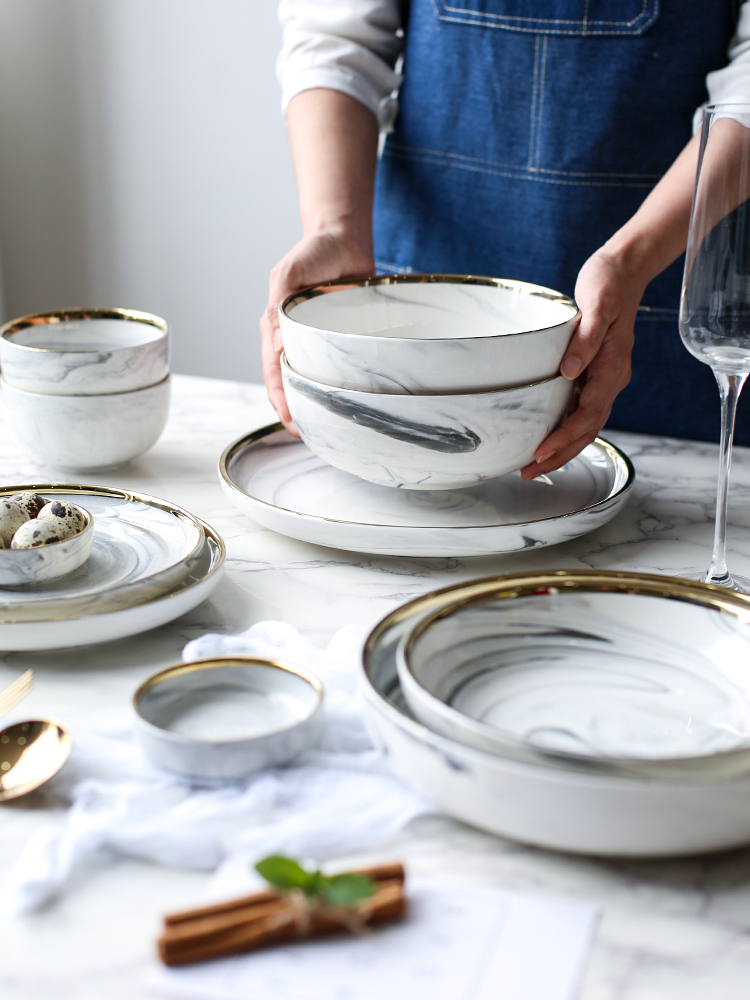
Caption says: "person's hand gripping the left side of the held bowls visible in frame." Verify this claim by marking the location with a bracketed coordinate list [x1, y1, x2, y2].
[260, 229, 375, 436]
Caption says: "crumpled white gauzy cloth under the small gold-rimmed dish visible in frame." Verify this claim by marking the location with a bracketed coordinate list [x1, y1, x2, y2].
[4, 622, 435, 913]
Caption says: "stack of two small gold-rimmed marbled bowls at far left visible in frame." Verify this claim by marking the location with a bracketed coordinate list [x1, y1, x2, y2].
[0, 309, 171, 472]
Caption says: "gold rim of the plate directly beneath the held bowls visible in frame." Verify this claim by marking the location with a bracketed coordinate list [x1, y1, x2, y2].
[217, 421, 635, 531]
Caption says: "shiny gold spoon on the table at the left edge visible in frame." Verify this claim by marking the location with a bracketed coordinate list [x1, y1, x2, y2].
[0, 719, 73, 802]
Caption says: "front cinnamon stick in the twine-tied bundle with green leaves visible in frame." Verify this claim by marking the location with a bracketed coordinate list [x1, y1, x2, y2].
[158, 879, 406, 966]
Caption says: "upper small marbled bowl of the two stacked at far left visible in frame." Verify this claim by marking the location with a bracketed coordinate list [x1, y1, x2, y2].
[0, 309, 169, 396]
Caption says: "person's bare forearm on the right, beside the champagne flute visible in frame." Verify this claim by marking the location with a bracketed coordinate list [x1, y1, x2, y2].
[602, 135, 700, 289]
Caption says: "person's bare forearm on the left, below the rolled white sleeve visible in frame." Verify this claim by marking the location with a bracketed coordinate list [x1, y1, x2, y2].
[287, 88, 378, 251]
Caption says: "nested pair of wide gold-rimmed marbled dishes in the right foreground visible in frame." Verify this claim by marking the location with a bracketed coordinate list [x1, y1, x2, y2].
[363, 570, 750, 856]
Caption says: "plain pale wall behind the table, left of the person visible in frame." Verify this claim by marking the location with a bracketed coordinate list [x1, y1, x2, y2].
[0, 0, 299, 381]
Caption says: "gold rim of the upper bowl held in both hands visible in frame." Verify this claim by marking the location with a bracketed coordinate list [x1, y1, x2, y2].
[279, 272, 581, 342]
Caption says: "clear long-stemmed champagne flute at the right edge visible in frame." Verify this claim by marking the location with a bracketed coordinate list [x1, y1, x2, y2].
[680, 102, 750, 592]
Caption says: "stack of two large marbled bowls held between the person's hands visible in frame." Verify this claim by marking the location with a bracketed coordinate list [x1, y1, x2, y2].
[279, 274, 579, 490]
